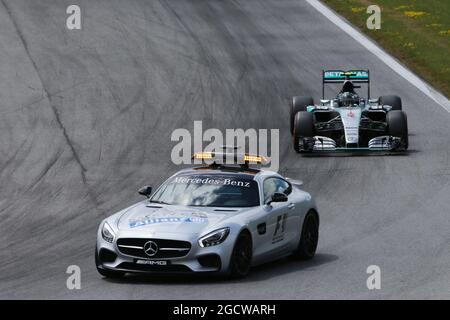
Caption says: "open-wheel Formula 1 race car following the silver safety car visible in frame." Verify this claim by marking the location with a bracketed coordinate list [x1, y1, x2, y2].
[290, 70, 408, 153]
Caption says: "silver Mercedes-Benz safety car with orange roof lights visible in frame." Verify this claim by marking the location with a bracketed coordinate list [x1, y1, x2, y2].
[95, 153, 319, 277]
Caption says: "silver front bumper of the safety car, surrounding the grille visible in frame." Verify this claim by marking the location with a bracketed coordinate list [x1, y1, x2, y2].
[96, 233, 234, 274]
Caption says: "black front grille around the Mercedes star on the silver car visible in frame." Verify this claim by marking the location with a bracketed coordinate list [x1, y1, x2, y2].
[117, 238, 191, 259]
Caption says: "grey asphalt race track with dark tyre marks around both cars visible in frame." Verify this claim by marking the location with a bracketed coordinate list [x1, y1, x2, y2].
[0, 0, 450, 299]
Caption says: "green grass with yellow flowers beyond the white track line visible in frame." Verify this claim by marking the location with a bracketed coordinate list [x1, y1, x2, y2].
[322, 0, 450, 97]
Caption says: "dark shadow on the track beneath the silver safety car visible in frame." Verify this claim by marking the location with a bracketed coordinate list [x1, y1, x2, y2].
[104, 253, 338, 285]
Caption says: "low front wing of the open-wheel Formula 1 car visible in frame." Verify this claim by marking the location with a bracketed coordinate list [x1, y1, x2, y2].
[299, 136, 406, 152]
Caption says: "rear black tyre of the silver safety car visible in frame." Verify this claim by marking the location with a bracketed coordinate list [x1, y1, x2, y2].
[294, 211, 319, 260]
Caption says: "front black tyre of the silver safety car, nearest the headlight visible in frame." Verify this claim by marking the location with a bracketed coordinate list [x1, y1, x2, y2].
[230, 231, 253, 279]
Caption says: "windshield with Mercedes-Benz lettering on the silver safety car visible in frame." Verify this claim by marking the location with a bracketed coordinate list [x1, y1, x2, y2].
[150, 174, 259, 207]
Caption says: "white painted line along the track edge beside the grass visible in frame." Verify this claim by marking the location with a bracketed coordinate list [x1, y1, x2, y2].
[306, 0, 450, 112]
